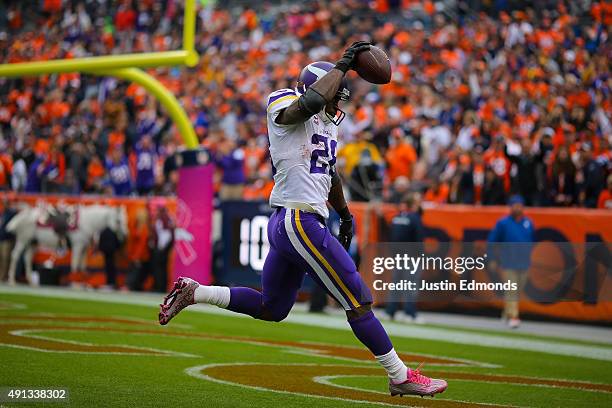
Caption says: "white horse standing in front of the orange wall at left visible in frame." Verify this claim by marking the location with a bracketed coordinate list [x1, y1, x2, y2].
[6, 205, 128, 285]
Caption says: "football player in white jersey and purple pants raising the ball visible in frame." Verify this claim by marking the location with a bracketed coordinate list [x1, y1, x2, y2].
[159, 41, 447, 395]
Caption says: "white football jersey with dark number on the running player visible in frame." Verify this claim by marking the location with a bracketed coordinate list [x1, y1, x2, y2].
[267, 89, 338, 218]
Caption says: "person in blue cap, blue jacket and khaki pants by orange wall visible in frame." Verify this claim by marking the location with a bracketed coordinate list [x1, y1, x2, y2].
[488, 195, 534, 329]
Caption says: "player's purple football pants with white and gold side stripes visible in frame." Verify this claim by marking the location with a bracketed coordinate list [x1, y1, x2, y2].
[227, 208, 393, 356]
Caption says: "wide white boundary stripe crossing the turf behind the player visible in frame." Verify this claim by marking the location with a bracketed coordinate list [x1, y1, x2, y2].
[0, 285, 612, 361]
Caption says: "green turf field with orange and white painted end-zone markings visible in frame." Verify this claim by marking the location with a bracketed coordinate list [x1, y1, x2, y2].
[0, 288, 612, 408]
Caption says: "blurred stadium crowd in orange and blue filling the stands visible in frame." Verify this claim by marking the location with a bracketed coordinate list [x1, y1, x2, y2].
[0, 0, 612, 208]
